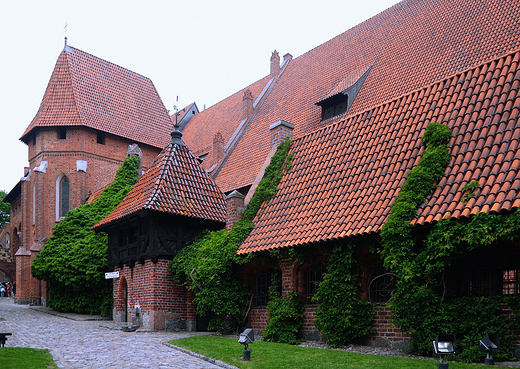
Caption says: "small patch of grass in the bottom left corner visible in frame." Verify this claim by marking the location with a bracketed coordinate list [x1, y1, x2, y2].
[0, 347, 57, 369]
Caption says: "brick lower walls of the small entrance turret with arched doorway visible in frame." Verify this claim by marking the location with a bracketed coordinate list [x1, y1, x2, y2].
[113, 259, 196, 330]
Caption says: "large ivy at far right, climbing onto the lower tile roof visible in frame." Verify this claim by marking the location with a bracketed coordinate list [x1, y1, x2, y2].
[381, 123, 520, 361]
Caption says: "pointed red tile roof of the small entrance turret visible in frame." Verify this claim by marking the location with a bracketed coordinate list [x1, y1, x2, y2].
[94, 131, 226, 228]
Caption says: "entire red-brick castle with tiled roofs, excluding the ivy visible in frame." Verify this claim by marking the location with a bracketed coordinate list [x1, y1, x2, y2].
[3, 0, 520, 344]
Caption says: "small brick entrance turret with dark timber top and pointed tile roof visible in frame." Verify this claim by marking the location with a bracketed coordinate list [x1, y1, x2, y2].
[94, 126, 226, 330]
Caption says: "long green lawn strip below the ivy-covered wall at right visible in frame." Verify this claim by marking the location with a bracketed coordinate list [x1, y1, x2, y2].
[169, 336, 479, 369]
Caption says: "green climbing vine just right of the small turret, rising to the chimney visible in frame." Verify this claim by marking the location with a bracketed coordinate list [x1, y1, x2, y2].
[170, 138, 292, 331]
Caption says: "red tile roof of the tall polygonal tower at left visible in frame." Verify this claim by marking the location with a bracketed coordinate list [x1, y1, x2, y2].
[21, 46, 173, 148]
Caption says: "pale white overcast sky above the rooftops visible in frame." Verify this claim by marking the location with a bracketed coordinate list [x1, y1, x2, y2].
[0, 0, 398, 192]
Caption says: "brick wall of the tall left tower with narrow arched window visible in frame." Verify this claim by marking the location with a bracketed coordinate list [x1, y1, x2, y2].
[15, 127, 160, 303]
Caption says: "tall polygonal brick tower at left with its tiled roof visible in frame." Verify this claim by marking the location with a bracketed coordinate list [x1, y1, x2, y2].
[6, 43, 173, 304]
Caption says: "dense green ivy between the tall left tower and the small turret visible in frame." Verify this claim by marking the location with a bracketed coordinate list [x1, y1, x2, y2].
[31, 156, 140, 315]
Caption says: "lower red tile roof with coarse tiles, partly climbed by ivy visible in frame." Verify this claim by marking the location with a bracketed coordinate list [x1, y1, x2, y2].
[239, 51, 520, 254]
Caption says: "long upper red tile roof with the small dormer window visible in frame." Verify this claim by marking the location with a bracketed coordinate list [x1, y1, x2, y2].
[185, 0, 520, 192]
